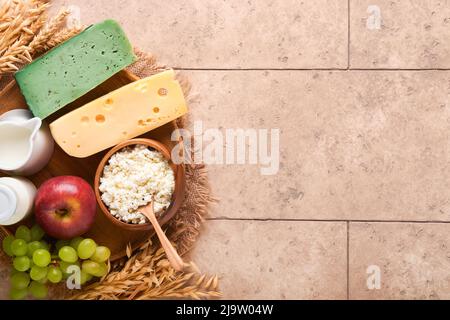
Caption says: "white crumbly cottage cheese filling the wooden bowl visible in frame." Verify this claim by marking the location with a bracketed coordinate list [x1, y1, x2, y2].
[99, 145, 175, 224]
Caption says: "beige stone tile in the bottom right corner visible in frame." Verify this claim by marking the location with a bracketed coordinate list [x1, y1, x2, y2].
[349, 223, 450, 299]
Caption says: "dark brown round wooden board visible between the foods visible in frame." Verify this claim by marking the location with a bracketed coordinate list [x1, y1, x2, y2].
[0, 71, 185, 261]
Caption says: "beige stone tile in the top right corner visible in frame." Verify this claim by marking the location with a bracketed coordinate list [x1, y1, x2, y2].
[350, 0, 450, 69]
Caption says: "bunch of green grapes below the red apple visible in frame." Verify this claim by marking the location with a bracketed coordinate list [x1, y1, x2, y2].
[2, 225, 111, 300]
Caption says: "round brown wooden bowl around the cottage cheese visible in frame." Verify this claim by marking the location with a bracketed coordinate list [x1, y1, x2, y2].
[94, 139, 185, 232]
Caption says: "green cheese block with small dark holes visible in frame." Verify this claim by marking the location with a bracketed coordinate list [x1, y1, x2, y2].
[15, 20, 136, 119]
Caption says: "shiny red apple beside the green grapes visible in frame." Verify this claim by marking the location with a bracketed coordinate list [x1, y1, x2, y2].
[34, 176, 97, 240]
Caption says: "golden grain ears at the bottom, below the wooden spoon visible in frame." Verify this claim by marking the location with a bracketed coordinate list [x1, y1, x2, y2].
[70, 241, 221, 300]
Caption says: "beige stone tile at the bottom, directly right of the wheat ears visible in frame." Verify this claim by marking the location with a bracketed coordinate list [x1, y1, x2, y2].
[193, 221, 347, 299]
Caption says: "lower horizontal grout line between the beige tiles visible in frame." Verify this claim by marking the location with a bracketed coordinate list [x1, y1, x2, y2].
[205, 217, 450, 224]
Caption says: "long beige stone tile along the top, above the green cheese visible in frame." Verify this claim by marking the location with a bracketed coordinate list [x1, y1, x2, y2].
[54, 0, 348, 68]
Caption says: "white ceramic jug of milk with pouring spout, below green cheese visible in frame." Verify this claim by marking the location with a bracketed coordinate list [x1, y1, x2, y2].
[0, 109, 54, 176]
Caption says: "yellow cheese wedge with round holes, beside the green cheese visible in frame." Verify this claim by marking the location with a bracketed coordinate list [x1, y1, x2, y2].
[50, 70, 187, 158]
